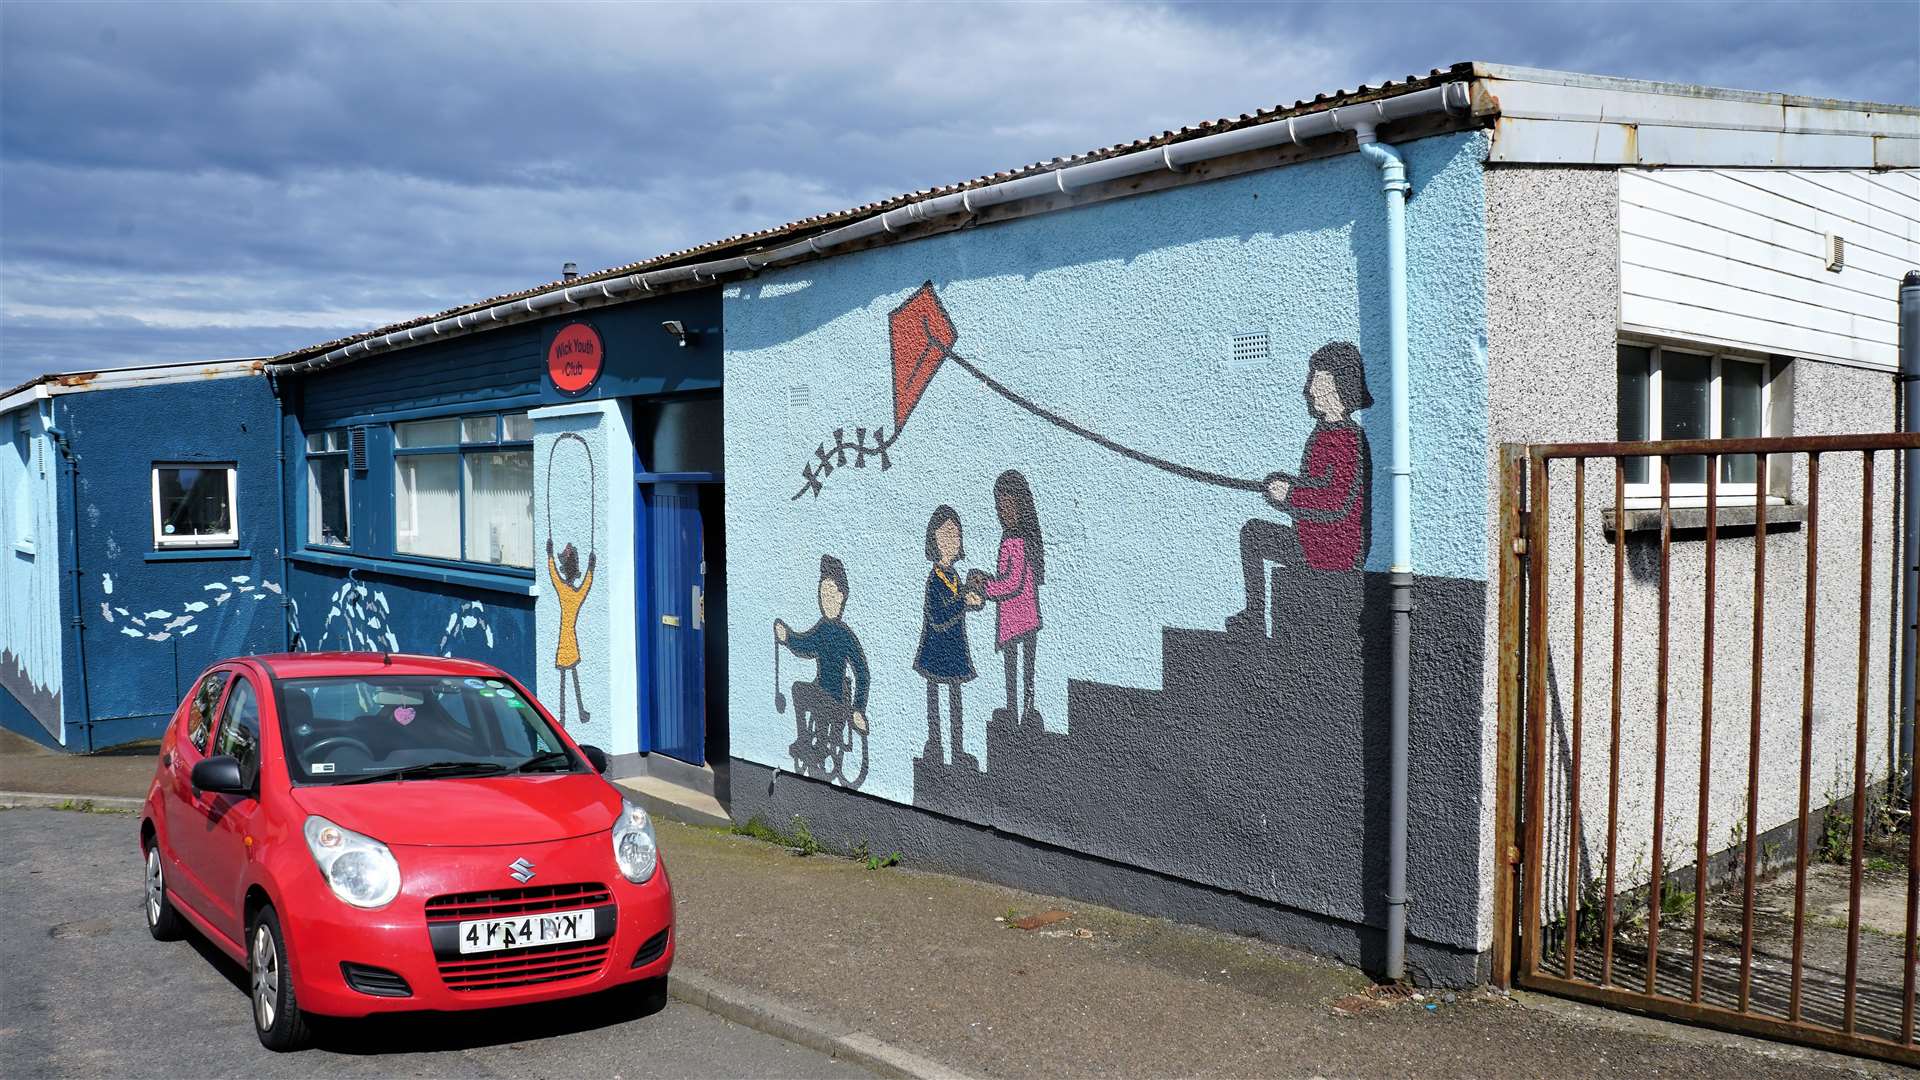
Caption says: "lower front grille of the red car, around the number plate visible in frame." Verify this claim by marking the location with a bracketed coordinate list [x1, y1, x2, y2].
[426, 882, 618, 992]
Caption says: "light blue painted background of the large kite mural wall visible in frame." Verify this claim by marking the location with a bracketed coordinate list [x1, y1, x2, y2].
[724, 133, 1486, 801]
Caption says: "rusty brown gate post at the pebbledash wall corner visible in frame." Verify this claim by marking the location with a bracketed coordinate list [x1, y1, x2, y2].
[1490, 442, 1526, 990]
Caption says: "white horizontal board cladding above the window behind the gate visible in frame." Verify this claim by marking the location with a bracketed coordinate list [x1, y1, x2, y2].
[1620, 169, 1920, 367]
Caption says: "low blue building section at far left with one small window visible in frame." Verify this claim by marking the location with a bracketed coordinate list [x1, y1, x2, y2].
[0, 359, 288, 751]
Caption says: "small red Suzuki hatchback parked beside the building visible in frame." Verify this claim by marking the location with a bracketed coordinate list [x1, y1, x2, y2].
[140, 653, 674, 1049]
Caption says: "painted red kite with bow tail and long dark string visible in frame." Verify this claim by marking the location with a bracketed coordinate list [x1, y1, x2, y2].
[793, 281, 1292, 500]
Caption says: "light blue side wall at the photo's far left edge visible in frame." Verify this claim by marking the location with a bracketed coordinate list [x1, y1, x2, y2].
[0, 402, 65, 740]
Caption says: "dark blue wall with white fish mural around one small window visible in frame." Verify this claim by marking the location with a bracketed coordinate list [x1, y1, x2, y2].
[54, 377, 286, 749]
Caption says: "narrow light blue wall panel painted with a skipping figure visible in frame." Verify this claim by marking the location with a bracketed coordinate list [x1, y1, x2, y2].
[532, 400, 639, 753]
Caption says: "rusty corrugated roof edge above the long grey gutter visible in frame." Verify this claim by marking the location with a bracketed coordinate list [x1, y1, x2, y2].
[271, 63, 1473, 363]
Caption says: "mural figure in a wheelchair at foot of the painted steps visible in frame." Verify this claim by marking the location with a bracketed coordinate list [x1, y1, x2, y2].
[774, 555, 872, 786]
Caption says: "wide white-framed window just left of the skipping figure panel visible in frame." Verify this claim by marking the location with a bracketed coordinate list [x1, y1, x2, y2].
[394, 413, 534, 569]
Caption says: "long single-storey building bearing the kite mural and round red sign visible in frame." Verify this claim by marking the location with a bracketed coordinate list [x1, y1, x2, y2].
[10, 63, 1920, 984]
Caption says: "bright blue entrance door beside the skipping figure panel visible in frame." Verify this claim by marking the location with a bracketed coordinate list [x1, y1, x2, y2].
[639, 482, 707, 765]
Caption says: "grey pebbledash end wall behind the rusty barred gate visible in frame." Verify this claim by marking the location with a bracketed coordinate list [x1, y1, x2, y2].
[1482, 165, 1920, 933]
